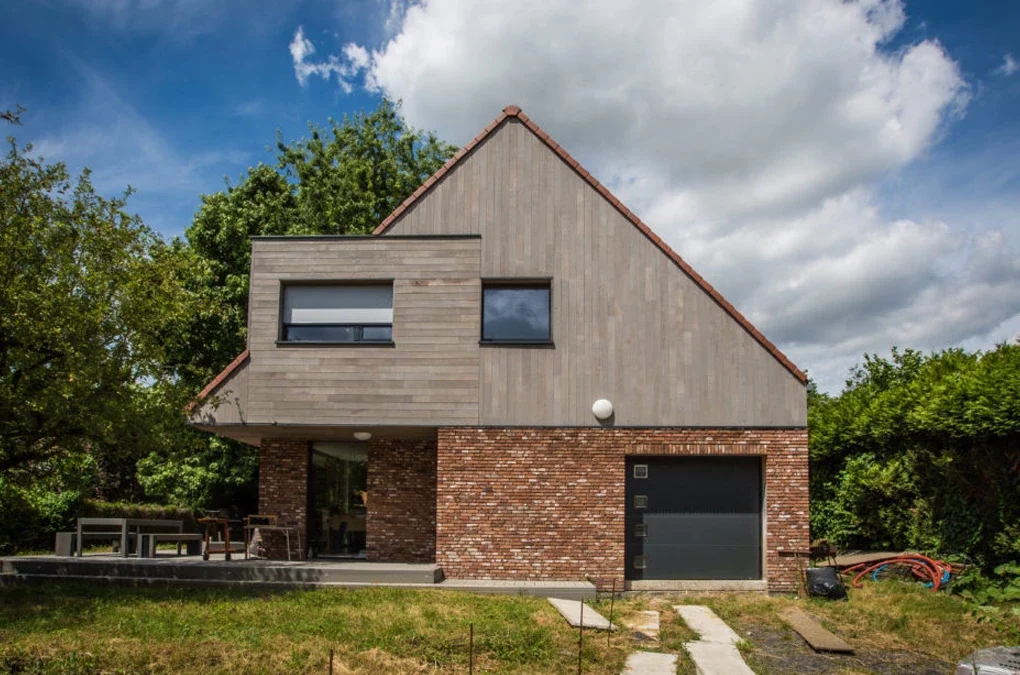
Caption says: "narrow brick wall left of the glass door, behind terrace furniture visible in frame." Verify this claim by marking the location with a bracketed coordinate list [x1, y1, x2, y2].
[258, 438, 309, 560]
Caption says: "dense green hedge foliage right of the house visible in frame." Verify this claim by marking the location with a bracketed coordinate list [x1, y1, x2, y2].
[809, 344, 1020, 568]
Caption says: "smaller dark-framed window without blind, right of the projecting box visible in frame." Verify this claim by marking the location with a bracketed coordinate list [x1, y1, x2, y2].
[481, 281, 552, 344]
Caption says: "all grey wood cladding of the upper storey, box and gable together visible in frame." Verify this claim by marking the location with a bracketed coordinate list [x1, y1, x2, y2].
[195, 118, 807, 428]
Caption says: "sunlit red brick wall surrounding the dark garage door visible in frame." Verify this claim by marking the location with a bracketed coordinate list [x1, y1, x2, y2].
[436, 427, 809, 590]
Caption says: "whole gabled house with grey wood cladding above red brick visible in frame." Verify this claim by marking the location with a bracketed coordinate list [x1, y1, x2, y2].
[192, 106, 809, 590]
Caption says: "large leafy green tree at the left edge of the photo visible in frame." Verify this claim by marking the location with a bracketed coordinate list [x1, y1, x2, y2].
[0, 113, 211, 551]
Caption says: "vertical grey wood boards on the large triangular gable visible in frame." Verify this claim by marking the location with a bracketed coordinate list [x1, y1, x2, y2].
[383, 119, 807, 426]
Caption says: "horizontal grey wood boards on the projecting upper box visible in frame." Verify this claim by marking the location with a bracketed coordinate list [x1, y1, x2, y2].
[209, 238, 481, 425]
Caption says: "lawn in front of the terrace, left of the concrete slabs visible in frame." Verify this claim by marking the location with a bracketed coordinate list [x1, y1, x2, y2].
[0, 583, 627, 675]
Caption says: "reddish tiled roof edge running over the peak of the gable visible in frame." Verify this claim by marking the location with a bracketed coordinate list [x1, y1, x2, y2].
[372, 105, 808, 382]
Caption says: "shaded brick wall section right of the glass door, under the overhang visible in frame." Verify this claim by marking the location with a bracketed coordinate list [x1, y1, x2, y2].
[365, 440, 436, 563]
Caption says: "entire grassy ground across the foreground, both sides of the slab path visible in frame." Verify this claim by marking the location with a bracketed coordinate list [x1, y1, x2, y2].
[0, 581, 1020, 675]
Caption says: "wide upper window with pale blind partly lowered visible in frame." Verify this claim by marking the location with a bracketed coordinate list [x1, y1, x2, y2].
[279, 283, 393, 343]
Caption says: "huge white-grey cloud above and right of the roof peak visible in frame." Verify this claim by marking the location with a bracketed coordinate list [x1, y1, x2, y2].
[296, 0, 1020, 388]
